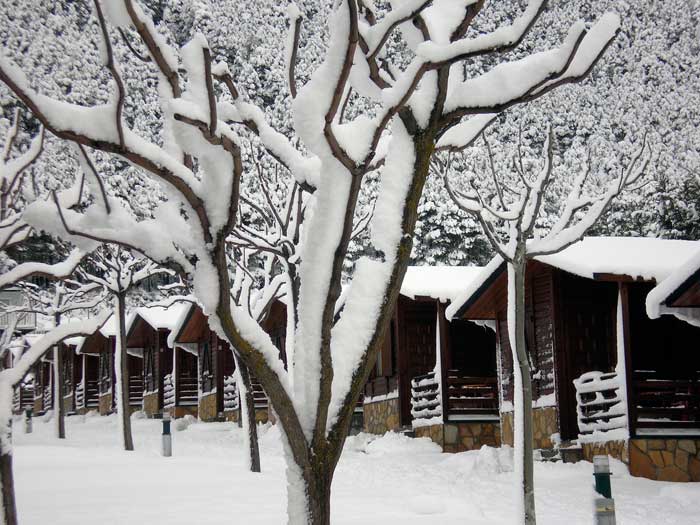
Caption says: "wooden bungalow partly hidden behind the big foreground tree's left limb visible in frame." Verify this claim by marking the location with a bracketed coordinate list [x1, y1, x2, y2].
[168, 302, 286, 422]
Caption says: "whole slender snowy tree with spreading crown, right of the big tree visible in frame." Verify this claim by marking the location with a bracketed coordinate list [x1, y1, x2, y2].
[442, 129, 650, 524]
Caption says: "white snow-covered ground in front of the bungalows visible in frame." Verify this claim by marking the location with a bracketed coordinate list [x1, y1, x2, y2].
[14, 416, 700, 525]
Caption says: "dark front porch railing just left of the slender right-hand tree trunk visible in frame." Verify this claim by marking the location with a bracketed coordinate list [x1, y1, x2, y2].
[446, 370, 498, 417]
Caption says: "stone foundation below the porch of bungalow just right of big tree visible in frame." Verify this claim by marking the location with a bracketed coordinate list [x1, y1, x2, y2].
[414, 421, 501, 452]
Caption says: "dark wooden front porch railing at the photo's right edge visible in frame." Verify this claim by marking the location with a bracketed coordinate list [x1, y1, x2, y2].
[633, 371, 700, 429]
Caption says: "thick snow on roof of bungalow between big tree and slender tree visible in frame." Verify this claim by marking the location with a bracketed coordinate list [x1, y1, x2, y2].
[401, 266, 483, 303]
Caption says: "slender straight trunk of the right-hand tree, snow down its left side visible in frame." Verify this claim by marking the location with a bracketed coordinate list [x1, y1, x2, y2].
[508, 255, 537, 525]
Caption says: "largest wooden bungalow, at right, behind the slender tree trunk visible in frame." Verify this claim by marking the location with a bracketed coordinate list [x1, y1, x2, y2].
[447, 238, 700, 481]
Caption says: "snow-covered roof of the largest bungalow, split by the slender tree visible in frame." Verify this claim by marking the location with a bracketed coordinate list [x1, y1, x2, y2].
[446, 237, 698, 318]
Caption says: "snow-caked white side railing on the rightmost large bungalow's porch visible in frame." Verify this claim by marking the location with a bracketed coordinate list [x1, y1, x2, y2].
[574, 372, 628, 436]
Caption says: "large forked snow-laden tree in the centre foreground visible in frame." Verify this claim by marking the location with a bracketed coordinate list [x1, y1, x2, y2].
[0, 0, 620, 524]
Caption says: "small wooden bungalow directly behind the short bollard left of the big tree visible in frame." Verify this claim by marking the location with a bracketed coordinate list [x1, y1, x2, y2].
[126, 304, 187, 417]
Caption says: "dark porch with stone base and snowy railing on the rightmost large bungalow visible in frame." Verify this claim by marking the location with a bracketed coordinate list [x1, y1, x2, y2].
[559, 277, 700, 481]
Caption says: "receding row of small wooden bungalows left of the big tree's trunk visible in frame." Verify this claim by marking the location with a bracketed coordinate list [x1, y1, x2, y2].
[39, 302, 286, 422]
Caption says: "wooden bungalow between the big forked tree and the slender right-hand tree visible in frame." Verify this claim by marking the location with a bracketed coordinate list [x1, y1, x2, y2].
[363, 267, 500, 452]
